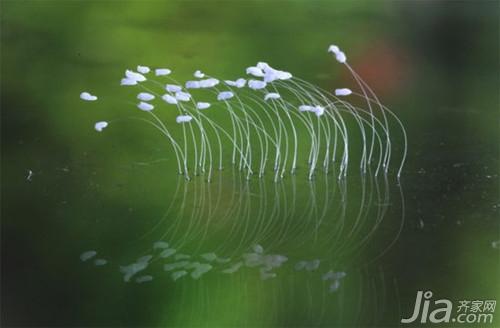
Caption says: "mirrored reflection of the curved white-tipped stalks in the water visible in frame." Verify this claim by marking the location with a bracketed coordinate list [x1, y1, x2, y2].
[81, 173, 402, 290]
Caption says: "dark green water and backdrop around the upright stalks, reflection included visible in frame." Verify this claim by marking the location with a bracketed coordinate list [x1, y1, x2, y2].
[1, 1, 500, 327]
